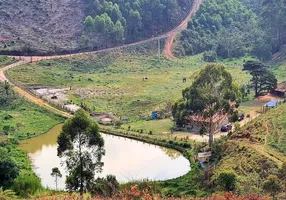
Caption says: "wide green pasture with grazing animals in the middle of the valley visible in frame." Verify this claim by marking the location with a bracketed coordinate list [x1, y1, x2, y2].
[9, 45, 286, 133]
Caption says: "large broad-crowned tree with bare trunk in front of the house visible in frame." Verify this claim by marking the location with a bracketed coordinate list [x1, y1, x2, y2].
[172, 64, 241, 147]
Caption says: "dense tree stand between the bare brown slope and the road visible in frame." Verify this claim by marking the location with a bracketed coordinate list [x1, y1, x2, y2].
[81, 0, 192, 49]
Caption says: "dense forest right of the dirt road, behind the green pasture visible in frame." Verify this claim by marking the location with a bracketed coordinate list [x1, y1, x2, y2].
[175, 0, 286, 61]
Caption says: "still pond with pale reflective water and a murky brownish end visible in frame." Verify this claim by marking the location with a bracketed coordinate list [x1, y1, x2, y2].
[20, 125, 190, 189]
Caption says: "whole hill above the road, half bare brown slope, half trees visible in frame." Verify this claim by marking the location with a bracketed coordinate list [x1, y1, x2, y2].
[0, 0, 193, 54]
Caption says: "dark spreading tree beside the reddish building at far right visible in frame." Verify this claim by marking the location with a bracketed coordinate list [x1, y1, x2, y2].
[243, 61, 277, 97]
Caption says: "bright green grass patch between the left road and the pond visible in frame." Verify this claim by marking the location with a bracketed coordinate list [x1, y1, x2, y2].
[0, 85, 64, 140]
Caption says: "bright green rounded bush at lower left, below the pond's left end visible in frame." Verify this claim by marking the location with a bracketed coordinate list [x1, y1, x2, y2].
[13, 172, 42, 197]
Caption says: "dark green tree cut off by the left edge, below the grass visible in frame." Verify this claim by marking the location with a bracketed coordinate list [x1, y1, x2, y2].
[0, 147, 19, 189]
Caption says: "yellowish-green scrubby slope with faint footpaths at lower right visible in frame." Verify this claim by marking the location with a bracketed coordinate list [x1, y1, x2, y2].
[214, 103, 286, 194]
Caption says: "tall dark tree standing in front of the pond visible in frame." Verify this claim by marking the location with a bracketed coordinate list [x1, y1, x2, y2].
[58, 109, 105, 194]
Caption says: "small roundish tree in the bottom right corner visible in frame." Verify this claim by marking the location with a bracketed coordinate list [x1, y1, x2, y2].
[262, 175, 282, 199]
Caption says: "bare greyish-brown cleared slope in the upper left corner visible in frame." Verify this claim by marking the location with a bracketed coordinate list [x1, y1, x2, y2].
[0, 0, 84, 54]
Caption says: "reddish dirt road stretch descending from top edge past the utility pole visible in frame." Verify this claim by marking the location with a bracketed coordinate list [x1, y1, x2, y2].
[163, 0, 203, 60]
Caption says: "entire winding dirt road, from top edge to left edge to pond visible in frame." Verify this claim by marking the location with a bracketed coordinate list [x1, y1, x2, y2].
[0, 0, 203, 117]
